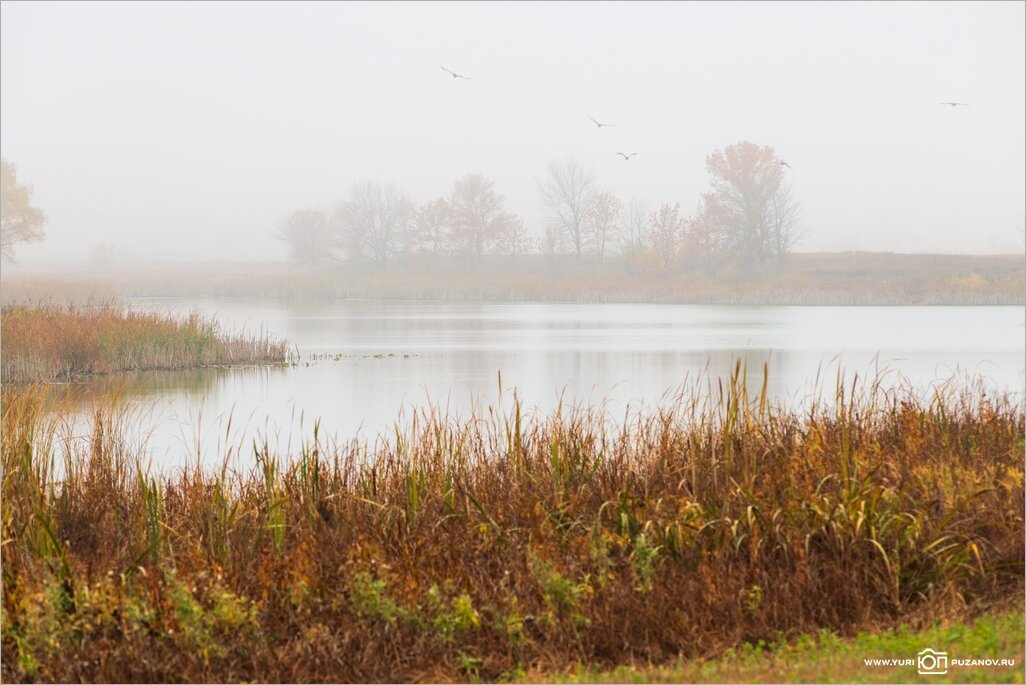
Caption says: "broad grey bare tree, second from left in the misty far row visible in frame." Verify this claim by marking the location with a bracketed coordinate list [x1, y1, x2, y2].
[334, 180, 413, 267]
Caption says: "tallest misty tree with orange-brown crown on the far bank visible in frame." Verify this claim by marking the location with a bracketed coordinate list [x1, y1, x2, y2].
[705, 140, 783, 268]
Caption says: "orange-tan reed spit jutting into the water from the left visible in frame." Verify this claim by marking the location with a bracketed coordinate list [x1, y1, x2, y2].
[0, 301, 287, 382]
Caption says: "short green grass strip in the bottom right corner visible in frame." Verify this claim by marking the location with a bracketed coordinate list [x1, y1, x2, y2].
[558, 599, 1024, 683]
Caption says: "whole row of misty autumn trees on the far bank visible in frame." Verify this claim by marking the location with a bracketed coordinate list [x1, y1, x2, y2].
[277, 142, 803, 273]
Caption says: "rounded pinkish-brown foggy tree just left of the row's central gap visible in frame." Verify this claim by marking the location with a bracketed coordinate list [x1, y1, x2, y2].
[448, 173, 522, 261]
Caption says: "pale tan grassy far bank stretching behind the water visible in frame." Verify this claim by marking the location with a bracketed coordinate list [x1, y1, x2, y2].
[2, 252, 1026, 305]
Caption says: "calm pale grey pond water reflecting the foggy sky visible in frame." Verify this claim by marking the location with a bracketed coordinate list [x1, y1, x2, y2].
[54, 299, 1026, 466]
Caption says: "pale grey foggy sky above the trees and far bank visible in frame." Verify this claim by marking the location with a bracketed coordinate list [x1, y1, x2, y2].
[0, 1, 1026, 264]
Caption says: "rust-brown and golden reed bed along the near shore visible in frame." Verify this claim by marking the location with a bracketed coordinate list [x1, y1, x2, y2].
[2, 368, 1024, 682]
